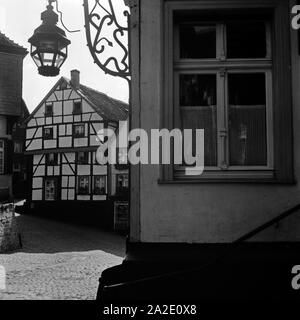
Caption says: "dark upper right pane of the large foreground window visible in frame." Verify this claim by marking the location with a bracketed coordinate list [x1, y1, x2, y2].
[226, 21, 267, 58]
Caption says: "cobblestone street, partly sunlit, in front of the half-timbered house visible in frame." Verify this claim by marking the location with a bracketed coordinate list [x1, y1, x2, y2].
[0, 216, 125, 300]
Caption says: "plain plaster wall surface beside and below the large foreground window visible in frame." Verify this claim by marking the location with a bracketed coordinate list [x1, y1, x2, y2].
[132, 0, 300, 243]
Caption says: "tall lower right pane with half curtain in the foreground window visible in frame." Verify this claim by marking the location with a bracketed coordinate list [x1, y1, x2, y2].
[228, 73, 267, 166]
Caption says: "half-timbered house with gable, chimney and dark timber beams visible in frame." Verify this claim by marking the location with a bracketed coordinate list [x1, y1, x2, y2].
[26, 70, 128, 224]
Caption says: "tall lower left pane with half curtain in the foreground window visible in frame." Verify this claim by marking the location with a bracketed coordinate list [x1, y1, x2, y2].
[180, 75, 217, 166]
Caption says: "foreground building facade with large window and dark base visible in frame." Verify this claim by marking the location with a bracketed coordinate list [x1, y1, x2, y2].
[100, 0, 300, 301]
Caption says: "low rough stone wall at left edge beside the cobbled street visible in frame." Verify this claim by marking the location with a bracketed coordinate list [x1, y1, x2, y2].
[0, 204, 20, 253]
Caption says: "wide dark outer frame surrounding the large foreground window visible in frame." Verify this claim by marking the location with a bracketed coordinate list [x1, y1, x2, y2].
[163, 0, 295, 183]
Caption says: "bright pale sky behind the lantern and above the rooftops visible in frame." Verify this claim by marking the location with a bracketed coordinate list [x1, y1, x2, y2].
[0, 0, 128, 111]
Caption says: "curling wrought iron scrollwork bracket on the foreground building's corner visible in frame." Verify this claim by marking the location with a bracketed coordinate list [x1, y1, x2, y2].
[84, 0, 131, 82]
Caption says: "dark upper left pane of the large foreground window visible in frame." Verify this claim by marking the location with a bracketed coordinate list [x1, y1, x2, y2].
[179, 24, 216, 59]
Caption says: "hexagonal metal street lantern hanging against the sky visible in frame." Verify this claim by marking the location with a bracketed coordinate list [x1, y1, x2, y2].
[28, 0, 71, 77]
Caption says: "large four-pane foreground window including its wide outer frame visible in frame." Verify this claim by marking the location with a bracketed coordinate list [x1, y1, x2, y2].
[162, 0, 293, 182]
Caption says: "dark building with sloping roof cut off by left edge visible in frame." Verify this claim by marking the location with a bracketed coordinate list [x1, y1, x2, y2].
[0, 33, 28, 201]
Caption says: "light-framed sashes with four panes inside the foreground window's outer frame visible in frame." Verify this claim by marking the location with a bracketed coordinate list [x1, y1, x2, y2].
[174, 19, 273, 178]
